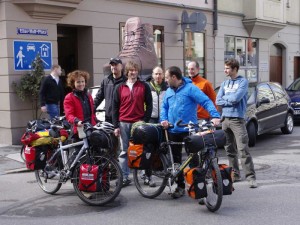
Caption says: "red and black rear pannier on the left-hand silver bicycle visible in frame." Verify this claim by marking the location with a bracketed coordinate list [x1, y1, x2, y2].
[24, 145, 51, 170]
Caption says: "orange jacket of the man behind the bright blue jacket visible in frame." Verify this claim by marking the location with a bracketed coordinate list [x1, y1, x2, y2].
[192, 75, 217, 119]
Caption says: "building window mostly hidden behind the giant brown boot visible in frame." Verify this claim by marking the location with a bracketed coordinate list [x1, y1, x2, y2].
[119, 23, 164, 68]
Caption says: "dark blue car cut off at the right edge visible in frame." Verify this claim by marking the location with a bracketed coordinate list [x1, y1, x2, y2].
[286, 78, 300, 121]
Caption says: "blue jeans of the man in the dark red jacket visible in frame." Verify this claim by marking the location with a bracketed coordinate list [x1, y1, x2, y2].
[119, 122, 132, 179]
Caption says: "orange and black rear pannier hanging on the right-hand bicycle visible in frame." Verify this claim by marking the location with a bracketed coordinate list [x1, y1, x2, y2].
[127, 141, 154, 170]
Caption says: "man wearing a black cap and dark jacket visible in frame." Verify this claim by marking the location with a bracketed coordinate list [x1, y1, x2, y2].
[94, 58, 126, 123]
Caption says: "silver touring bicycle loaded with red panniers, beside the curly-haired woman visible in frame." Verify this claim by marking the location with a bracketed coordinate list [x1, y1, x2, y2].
[21, 118, 123, 206]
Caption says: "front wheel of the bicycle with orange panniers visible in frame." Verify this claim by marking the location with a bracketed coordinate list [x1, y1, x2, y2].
[204, 159, 223, 212]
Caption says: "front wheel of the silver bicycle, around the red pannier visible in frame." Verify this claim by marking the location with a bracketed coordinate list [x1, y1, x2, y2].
[72, 155, 123, 206]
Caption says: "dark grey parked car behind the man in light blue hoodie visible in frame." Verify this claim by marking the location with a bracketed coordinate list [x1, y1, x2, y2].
[215, 82, 294, 147]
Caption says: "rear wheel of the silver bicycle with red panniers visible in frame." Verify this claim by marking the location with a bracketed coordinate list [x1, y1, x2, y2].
[34, 149, 63, 194]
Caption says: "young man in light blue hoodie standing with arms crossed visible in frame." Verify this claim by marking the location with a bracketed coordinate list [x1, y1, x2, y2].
[216, 59, 257, 188]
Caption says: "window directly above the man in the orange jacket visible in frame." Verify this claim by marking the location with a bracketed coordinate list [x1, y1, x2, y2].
[184, 30, 206, 77]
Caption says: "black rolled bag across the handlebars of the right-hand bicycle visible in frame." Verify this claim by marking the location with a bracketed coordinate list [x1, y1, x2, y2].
[184, 130, 226, 153]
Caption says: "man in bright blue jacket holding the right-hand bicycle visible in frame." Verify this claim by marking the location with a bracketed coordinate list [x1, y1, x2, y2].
[160, 66, 220, 198]
